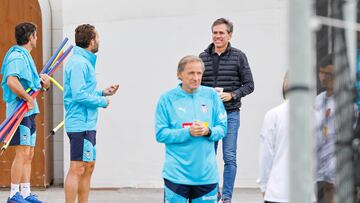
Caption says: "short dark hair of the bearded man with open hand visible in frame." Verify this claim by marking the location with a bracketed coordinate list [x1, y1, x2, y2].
[75, 24, 96, 48]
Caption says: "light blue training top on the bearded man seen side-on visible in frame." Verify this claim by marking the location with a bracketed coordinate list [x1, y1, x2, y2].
[64, 46, 107, 132]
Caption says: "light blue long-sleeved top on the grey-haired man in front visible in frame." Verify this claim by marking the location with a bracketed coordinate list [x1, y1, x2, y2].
[155, 84, 227, 185]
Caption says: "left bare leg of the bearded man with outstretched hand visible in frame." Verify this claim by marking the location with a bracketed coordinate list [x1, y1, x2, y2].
[65, 161, 86, 203]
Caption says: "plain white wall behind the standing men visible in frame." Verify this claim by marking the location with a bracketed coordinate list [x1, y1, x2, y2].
[62, 0, 287, 188]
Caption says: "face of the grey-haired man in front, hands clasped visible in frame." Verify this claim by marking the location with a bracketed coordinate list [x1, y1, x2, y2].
[178, 61, 204, 93]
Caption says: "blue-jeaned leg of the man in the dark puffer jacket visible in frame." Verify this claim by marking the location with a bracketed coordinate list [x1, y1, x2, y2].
[222, 111, 240, 202]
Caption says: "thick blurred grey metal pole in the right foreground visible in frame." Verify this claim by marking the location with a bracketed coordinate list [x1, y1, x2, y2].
[288, 0, 315, 203]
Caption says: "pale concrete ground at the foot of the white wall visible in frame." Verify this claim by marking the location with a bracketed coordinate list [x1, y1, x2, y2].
[0, 187, 262, 203]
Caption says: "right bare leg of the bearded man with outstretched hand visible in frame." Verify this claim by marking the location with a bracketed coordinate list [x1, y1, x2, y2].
[78, 161, 95, 203]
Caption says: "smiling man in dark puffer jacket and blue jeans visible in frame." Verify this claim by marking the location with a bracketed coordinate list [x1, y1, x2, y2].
[200, 18, 254, 203]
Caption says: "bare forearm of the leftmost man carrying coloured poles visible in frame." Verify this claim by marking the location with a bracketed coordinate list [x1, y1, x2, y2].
[6, 76, 34, 110]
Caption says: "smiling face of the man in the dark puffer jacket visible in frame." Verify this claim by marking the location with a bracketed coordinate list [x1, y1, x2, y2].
[212, 24, 232, 49]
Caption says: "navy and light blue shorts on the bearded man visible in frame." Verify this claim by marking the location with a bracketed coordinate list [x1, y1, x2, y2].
[67, 130, 96, 162]
